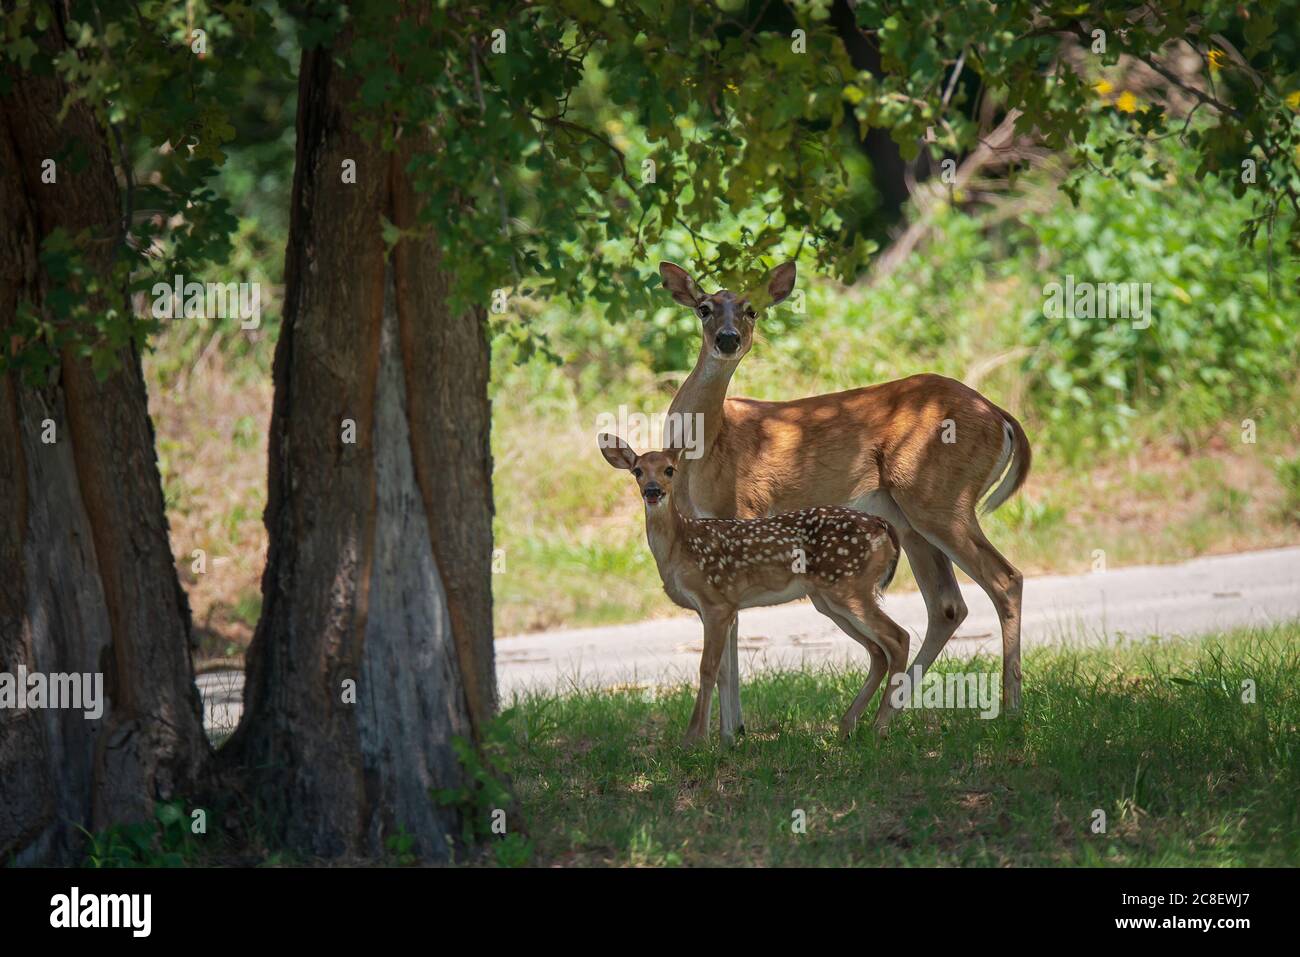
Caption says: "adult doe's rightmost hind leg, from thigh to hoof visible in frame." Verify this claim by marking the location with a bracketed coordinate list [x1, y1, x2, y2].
[907, 507, 1024, 711]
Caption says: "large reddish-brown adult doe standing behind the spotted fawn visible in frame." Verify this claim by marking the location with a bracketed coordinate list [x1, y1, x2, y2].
[659, 261, 1032, 733]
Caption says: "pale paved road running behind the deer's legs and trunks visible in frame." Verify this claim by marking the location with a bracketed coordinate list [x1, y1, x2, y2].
[199, 547, 1300, 727]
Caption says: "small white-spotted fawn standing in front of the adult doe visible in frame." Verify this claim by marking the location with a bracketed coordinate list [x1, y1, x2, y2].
[599, 433, 910, 744]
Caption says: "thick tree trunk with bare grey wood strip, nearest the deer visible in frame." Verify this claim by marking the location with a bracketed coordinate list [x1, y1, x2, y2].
[224, 33, 495, 859]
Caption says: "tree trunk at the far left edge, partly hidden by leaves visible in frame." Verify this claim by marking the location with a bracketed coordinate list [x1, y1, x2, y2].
[0, 50, 209, 863]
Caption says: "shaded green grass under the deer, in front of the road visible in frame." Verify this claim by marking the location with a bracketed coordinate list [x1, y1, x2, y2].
[514, 622, 1300, 866]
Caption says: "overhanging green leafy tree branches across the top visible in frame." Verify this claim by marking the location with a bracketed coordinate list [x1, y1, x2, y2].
[0, 0, 1300, 376]
